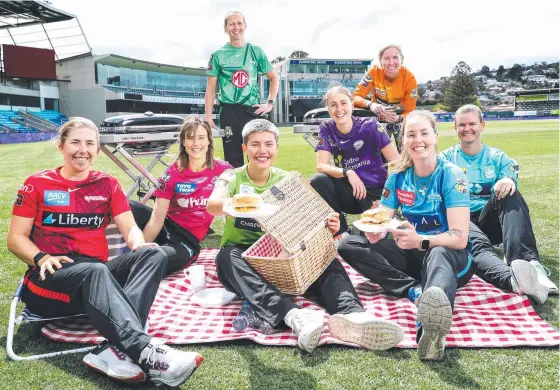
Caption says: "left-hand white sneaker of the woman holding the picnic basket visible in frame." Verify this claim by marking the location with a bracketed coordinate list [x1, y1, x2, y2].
[284, 309, 325, 353]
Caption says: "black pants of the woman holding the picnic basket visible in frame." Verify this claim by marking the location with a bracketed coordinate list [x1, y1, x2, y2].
[216, 245, 364, 326]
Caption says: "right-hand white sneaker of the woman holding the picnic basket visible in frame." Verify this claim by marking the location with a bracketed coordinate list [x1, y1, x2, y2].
[329, 311, 404, 350]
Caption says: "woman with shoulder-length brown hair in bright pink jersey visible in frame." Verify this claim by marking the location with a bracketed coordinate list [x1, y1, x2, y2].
[130, 116, 232, 274]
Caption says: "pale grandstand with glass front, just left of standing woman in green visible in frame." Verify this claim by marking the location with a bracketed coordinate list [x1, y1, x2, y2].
[56, 53, 218, 123]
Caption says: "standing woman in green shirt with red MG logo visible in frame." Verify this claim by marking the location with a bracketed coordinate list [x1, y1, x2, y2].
[204, 11, 280, 168]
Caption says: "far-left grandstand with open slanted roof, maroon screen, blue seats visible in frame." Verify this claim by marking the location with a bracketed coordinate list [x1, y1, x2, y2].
[0, 1, 91, 143]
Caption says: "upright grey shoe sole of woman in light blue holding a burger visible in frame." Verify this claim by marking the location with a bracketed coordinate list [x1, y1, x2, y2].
[418, 287, 453, 361]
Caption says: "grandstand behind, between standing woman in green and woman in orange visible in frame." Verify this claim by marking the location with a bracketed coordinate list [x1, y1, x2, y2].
[263, 58, 372, 123]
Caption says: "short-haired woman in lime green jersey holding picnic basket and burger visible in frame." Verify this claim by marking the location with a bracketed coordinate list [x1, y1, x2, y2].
[206, 119, 403, 352]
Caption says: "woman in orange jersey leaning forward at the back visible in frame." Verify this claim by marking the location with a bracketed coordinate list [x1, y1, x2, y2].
[352, 45, 418, 153]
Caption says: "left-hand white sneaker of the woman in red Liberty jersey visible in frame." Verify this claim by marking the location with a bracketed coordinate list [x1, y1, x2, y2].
[82, 341, 146, 383]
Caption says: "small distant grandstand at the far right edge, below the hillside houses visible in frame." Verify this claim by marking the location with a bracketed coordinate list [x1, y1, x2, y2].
[515, 88, 560, 116]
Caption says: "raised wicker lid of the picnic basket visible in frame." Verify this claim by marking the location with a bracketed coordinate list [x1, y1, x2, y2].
[255, 172, 333, 254]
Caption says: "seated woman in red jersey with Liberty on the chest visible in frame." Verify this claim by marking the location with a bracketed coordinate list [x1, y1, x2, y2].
[8, 118, 202, 386]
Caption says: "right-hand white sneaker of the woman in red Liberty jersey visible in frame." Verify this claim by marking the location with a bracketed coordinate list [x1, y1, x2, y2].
[139, 340, 204, 387]
